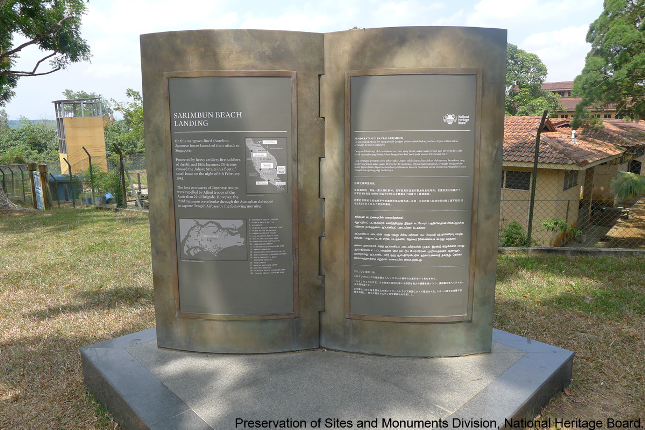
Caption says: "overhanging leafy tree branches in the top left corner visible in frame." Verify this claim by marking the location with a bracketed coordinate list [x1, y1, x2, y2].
[0, 0, 90, 106]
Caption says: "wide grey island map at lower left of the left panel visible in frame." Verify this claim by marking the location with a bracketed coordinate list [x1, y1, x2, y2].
[179, 219, 247, 261]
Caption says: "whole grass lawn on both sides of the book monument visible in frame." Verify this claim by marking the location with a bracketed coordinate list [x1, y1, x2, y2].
[0, 208, 645, 430]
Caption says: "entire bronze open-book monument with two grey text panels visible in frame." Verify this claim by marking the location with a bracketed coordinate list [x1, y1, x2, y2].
[141, 27, 506, 357]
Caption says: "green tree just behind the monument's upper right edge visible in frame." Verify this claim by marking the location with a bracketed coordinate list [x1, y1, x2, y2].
[506, 43, 563, 116]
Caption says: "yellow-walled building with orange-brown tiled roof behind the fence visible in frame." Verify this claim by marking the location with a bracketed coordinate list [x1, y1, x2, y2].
[500, 116, 645, 245]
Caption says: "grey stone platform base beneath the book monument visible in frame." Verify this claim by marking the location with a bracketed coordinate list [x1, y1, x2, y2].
[81, 328, 573, 430]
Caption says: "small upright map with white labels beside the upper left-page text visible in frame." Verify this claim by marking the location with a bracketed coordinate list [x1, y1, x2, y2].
[246, 137, 287, 194]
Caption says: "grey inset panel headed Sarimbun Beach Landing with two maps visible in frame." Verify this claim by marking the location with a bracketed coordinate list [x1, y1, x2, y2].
[168, 76, 297, 317]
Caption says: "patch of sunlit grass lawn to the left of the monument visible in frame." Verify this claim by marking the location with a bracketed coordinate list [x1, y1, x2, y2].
[0, 208, 154, 429]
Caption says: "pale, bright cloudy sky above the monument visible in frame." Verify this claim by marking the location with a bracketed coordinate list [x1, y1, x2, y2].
[5, 0, 603, 119]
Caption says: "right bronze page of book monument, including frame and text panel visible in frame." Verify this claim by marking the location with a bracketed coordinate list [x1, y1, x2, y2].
[320, 27, 506, 357]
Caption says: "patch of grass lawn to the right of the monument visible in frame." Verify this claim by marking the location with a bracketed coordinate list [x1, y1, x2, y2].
[494, 254, 645, 419]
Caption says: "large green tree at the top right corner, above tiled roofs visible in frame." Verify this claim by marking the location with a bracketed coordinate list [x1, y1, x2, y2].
[573, 0, 645, 121]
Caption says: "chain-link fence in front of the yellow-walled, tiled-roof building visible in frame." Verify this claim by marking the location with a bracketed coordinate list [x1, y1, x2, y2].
[499, 153, 645, 248]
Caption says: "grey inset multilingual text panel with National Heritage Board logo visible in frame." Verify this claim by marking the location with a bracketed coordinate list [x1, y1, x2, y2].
[346, 71, 478, 321]
